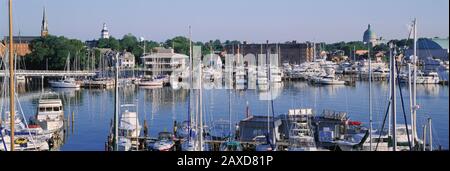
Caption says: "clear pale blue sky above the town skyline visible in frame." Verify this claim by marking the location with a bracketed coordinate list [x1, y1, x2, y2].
[0, 0, 449, 42]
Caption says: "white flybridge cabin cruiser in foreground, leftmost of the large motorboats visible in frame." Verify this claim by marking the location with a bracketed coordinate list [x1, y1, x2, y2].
[36, 93, 64, 133]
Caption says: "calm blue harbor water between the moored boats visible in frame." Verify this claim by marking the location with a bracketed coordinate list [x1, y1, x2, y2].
[3, 81, 449, 151]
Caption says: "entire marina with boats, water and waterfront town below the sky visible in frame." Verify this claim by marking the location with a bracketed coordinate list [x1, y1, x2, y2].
[0, 0, 449, 152]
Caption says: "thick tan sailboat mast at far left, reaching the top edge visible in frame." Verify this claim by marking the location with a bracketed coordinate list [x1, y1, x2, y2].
[9, 0, 16, 151]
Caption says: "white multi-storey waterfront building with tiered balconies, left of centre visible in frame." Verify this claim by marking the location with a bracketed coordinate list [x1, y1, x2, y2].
[141, 47, 189, 77]
